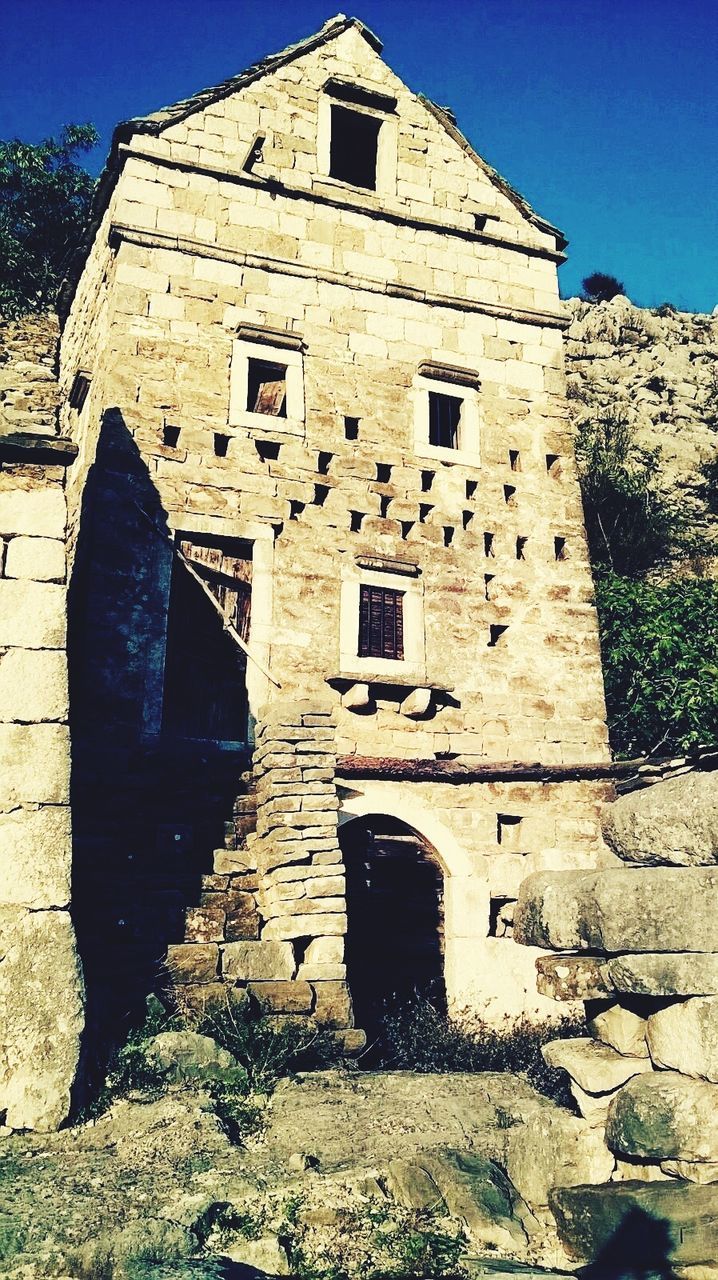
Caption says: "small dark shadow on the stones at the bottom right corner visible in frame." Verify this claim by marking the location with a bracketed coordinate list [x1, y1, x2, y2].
[577, 1208, 677, 1280]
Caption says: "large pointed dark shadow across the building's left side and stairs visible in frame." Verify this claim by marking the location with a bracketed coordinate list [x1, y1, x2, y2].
[68, 410, 248, 1102]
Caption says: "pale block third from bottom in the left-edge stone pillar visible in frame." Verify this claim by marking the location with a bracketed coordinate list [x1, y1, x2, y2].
[0, 724, 70, 804]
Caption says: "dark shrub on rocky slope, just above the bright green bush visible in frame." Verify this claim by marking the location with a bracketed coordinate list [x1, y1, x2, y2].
[576, 411, 682, 575]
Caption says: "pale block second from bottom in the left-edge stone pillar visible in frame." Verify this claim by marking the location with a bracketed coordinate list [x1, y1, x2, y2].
[0, 805, 72, 910]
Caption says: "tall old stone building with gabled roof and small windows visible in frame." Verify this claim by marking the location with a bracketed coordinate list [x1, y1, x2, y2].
[0, 17, 610, 1123]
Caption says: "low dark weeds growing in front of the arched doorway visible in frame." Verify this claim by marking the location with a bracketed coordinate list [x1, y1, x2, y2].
[378, 996, 581, 1107]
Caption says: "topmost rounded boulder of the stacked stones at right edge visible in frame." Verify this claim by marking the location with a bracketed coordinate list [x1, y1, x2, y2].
[603, 772, 718, 867]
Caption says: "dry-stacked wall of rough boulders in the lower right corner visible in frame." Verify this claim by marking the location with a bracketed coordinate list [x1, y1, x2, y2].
[517, 768, 718, 1276]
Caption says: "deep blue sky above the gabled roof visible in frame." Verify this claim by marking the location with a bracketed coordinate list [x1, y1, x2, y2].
[0, 0, 718, 311]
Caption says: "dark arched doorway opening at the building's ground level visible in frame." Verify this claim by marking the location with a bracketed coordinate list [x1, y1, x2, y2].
[339, 814, 445, 1034]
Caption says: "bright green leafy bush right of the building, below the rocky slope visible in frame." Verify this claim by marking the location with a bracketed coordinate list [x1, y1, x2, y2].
[596, 571, 718, 756]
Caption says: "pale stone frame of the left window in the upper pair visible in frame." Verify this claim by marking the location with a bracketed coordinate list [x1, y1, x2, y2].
[229, 338, 305, 436]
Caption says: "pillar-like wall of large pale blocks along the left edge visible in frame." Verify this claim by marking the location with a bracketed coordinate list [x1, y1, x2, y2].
[0, 453, 83, 1129]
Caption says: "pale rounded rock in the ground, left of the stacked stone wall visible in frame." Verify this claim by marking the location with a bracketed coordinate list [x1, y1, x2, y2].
[504, 1107, 614, 1211]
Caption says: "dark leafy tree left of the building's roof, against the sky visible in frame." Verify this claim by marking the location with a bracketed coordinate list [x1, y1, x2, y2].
[0, 124, 99, 316]
